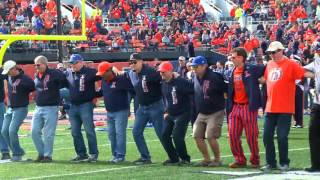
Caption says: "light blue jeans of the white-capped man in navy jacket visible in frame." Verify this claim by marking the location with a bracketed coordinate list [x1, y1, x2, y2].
[1, 107, 28, 156]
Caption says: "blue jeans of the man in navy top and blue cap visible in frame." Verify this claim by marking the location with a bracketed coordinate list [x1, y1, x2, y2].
[69, 102, 99, 157]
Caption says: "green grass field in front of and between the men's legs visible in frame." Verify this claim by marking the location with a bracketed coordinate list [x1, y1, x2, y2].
[0, 111, 310, 180]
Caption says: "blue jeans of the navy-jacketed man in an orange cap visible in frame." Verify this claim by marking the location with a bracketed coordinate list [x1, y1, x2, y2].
[107, 109, 129, 158]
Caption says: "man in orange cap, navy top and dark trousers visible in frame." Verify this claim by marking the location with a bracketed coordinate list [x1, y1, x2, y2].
[158, 62, 194, 165]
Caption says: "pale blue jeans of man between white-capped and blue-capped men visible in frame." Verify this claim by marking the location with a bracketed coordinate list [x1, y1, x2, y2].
[32, 106, 59, 157]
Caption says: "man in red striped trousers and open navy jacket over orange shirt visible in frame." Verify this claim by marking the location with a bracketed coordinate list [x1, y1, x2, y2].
[227, 48, 264, 168]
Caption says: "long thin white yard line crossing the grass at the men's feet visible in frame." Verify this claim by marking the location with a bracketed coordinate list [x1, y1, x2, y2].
[20, 148, 309, 180]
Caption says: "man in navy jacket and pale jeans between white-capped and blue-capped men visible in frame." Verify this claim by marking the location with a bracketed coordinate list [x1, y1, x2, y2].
[32, 56, 68, 163]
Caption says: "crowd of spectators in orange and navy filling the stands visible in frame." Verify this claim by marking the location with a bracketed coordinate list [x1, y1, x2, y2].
[0, 0, 320, 57]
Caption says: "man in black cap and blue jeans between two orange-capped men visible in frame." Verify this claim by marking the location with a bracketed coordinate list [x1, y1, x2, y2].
[129, 53, 164, 164]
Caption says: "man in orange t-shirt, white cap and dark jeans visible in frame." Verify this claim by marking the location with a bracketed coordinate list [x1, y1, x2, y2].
[261, 41, 313, 171]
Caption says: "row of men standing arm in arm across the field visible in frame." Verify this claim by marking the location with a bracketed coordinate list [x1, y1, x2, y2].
[0, 41, 320, 171]
